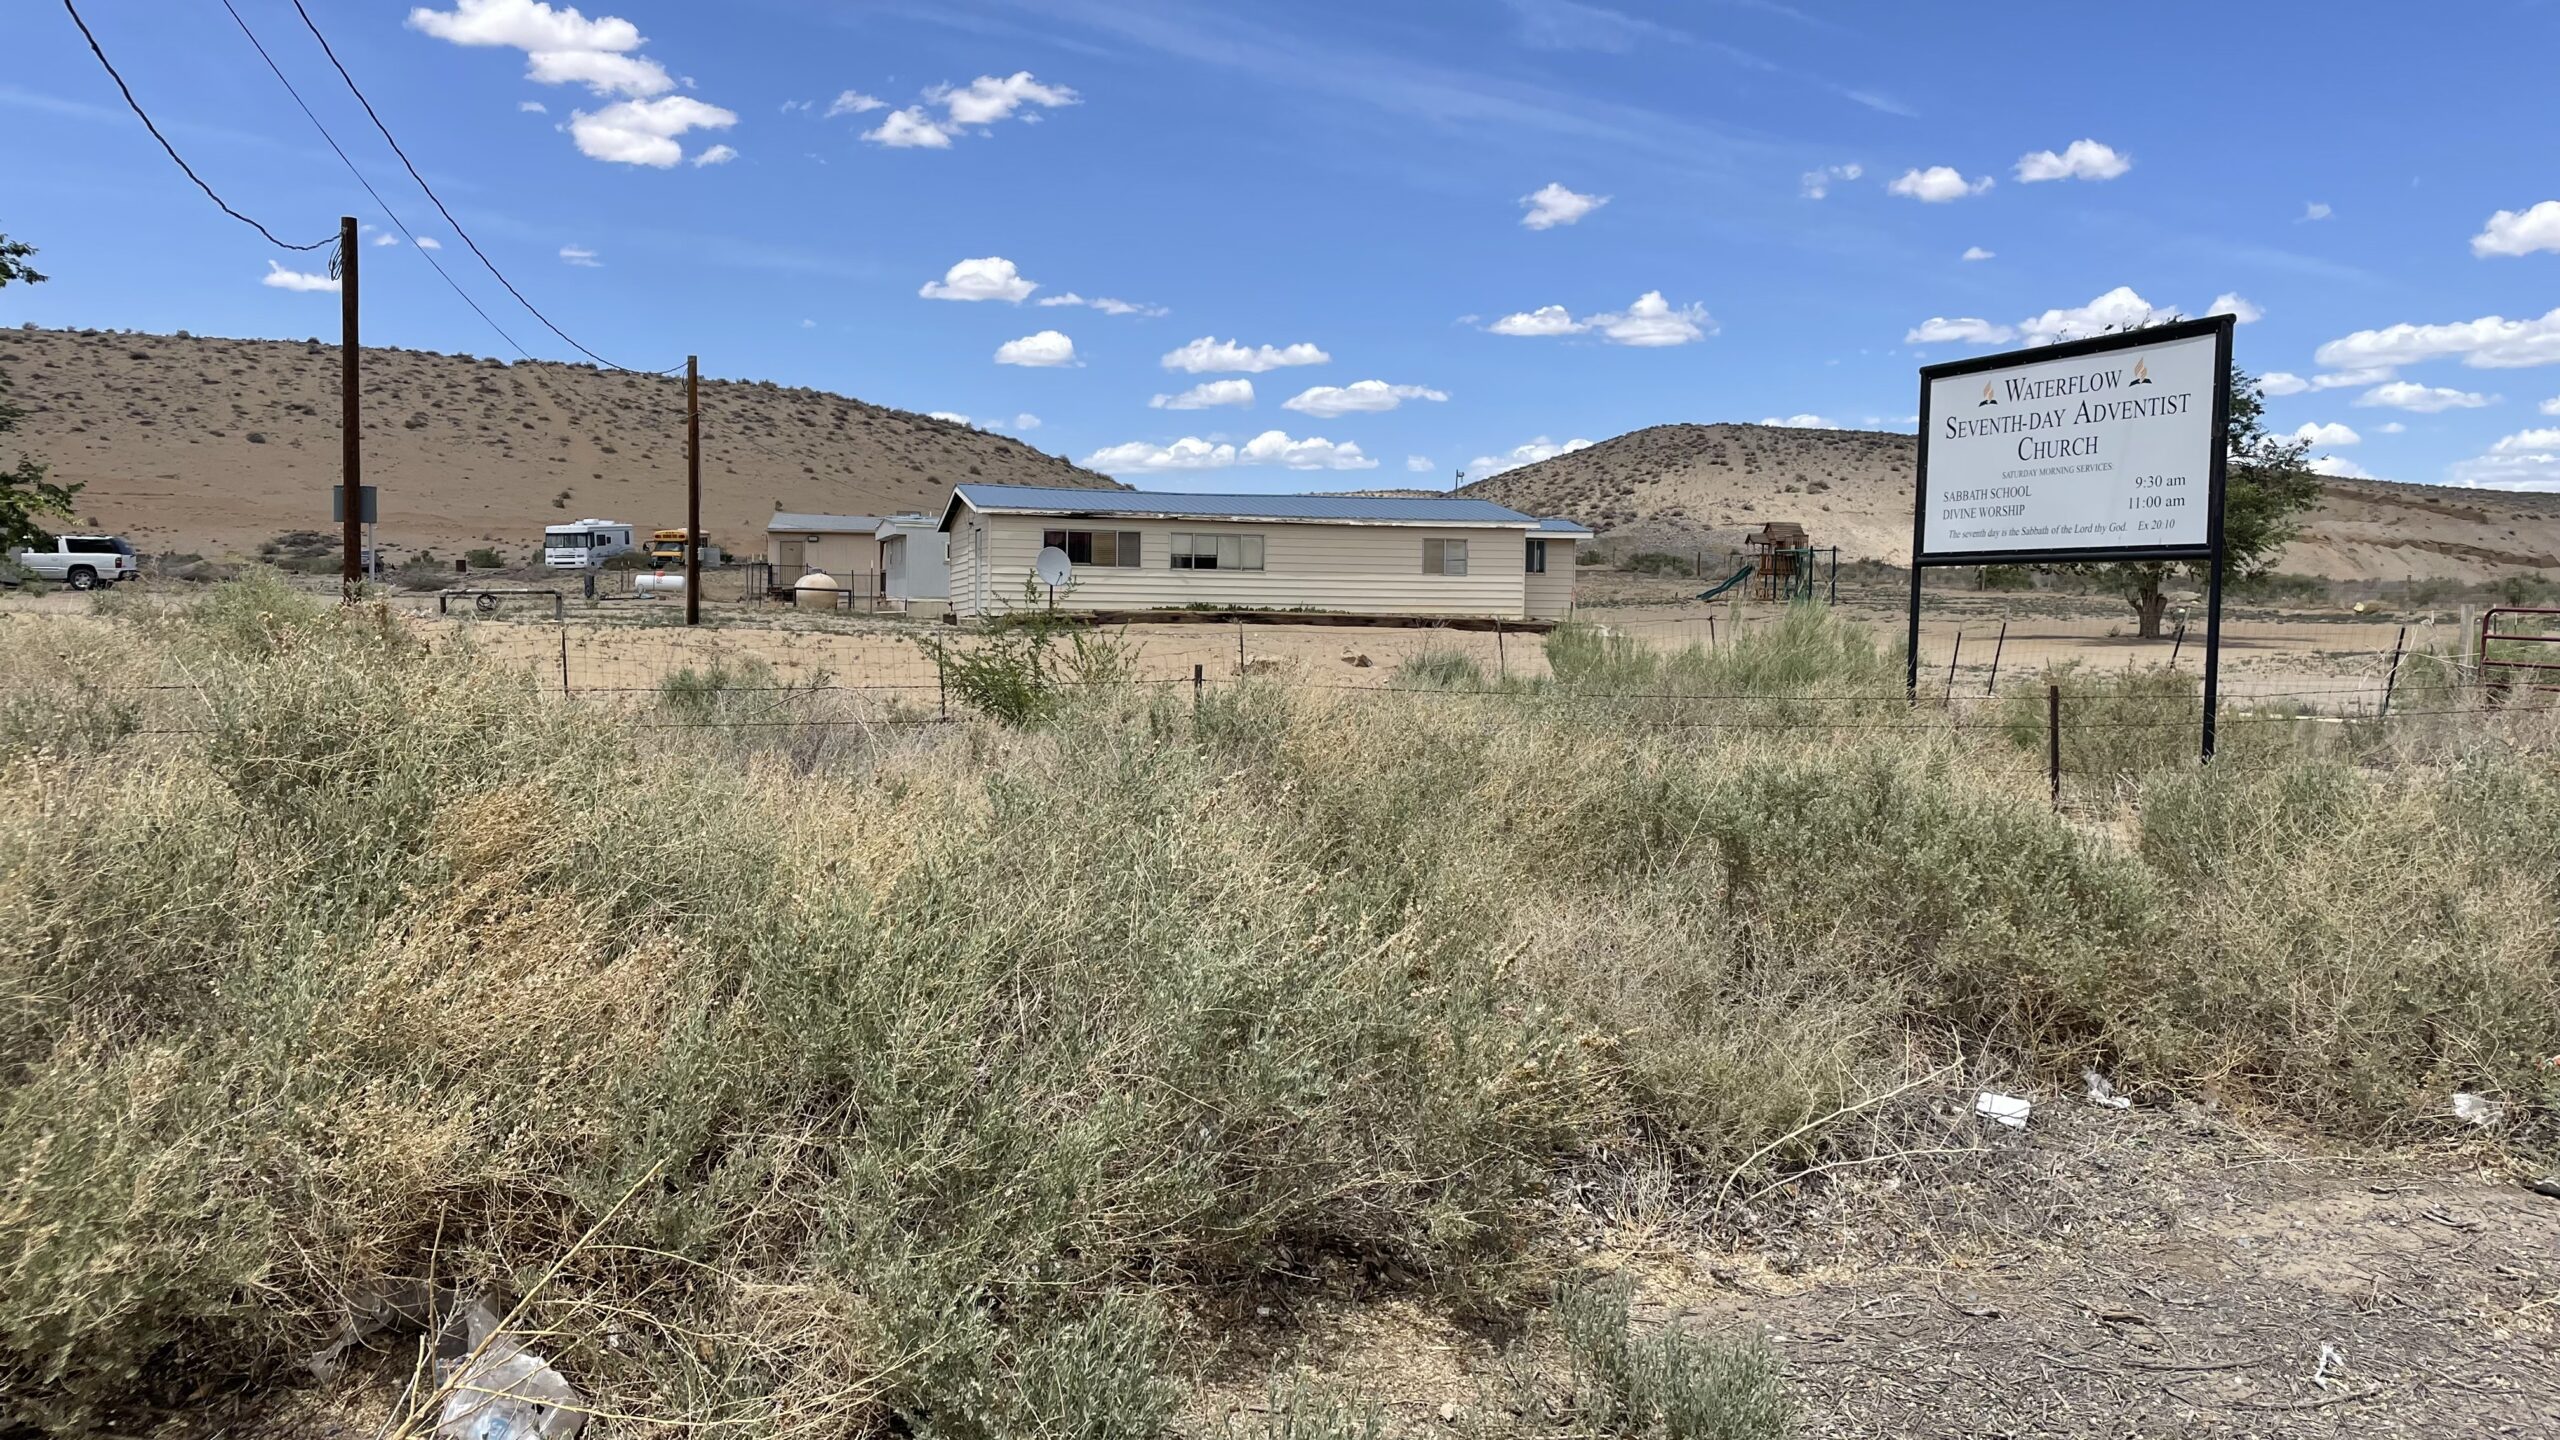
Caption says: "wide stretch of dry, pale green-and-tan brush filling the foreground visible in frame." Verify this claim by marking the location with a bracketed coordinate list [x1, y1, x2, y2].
[0, 582, 2560, 1437]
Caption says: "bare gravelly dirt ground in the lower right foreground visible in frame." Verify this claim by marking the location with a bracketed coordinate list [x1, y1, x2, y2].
[1201, 1097, 2560, 1440]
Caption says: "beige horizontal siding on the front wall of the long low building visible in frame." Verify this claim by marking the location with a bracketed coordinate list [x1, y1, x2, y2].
[952, 507, 1526, 618]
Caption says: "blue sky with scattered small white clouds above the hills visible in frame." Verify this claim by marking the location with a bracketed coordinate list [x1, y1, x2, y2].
[0, 0, 2560, 489]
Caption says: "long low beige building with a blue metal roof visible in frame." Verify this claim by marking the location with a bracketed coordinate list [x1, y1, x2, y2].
[940, 484, 1590, 620]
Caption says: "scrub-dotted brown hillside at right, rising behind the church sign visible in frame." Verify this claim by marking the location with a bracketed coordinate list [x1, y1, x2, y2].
[1467, 425, 2560, 579]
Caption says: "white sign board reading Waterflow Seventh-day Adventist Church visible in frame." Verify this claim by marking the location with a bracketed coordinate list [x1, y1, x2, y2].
[1917, 333, 2222, 559]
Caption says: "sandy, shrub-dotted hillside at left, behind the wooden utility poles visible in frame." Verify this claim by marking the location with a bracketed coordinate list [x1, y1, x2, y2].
[0, 328, 1114, 559]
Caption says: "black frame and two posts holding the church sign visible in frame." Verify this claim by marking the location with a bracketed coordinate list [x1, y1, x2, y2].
[1905, 315, 2237, 761]
